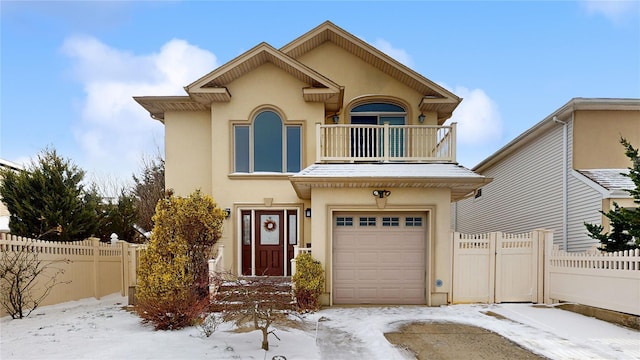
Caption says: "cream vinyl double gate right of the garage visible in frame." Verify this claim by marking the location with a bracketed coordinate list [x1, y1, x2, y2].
[452, 230, 544, 303]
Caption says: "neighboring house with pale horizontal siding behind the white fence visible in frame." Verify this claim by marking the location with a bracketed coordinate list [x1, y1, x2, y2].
[452, 98, 640, 251]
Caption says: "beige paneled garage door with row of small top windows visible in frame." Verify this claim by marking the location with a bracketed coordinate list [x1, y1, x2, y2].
[333, 212, 427, 304]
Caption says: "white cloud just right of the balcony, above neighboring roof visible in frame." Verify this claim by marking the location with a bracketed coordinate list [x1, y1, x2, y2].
[449, 86, 502, 146]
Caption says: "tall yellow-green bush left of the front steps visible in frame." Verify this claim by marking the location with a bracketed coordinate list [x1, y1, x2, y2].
[136, 191, 224, 330]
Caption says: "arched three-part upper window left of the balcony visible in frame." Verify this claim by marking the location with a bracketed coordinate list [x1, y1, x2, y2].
[234, 110, 302, 173]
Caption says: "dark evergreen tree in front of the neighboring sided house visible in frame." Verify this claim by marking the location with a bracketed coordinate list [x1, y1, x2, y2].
[585, 138, 640, 252]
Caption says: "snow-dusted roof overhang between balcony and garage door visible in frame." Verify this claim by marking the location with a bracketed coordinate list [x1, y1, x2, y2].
[289, 163, 493, 201]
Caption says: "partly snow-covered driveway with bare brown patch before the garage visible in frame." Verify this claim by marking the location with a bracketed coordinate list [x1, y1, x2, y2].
[307, 304, 640, 360]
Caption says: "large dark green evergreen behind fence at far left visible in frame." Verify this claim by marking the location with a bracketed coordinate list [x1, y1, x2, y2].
[0, 148, 99, 241]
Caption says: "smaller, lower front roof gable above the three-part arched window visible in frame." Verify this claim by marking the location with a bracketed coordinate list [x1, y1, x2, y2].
[185, 42, 342, 104]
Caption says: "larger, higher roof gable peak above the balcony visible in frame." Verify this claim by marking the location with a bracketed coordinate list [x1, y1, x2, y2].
[280, 21, 462, 123]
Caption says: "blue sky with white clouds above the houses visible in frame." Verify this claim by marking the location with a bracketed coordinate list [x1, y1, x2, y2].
[0, 0, 640, 186]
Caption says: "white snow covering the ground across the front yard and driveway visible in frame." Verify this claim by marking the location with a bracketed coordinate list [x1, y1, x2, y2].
[0, 295, 640, 360]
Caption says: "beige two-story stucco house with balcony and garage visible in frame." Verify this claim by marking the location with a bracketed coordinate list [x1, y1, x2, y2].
[135, 22, 490, 305]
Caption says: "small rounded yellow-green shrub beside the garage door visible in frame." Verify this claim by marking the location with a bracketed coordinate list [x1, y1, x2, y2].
[291, 253, 324, 312]
